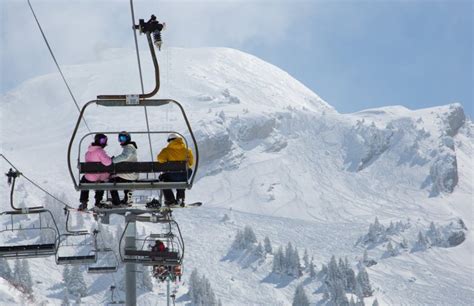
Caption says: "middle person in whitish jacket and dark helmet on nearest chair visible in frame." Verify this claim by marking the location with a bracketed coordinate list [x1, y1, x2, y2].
[110, 131, 138, 206]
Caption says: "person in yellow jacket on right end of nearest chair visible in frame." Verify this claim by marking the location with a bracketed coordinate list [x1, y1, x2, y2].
[156, 133, 194, 205]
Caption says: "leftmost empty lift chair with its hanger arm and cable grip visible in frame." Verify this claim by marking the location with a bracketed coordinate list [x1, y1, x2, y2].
[0, 169, 59, 258]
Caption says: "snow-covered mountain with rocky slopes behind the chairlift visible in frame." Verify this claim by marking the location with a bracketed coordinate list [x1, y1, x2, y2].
[0, 48, 474, 305]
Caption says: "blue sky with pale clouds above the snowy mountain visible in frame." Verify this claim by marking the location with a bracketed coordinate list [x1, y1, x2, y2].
[0, 0, 474, 118]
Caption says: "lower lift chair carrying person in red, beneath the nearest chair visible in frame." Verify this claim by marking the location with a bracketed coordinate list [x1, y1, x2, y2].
[120, 220, 184, 267]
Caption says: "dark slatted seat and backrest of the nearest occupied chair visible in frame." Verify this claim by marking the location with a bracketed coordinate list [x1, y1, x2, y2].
[77, 161, 191, 190]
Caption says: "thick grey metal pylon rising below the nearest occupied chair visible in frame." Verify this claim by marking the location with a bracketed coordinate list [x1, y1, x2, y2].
[125, 220, 137, 306]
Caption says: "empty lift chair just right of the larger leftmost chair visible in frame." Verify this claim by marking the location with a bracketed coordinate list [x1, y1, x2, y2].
[56, 209, 97, 265]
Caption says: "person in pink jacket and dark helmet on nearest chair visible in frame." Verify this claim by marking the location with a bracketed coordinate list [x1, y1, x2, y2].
[78, 134, 112, 210]
